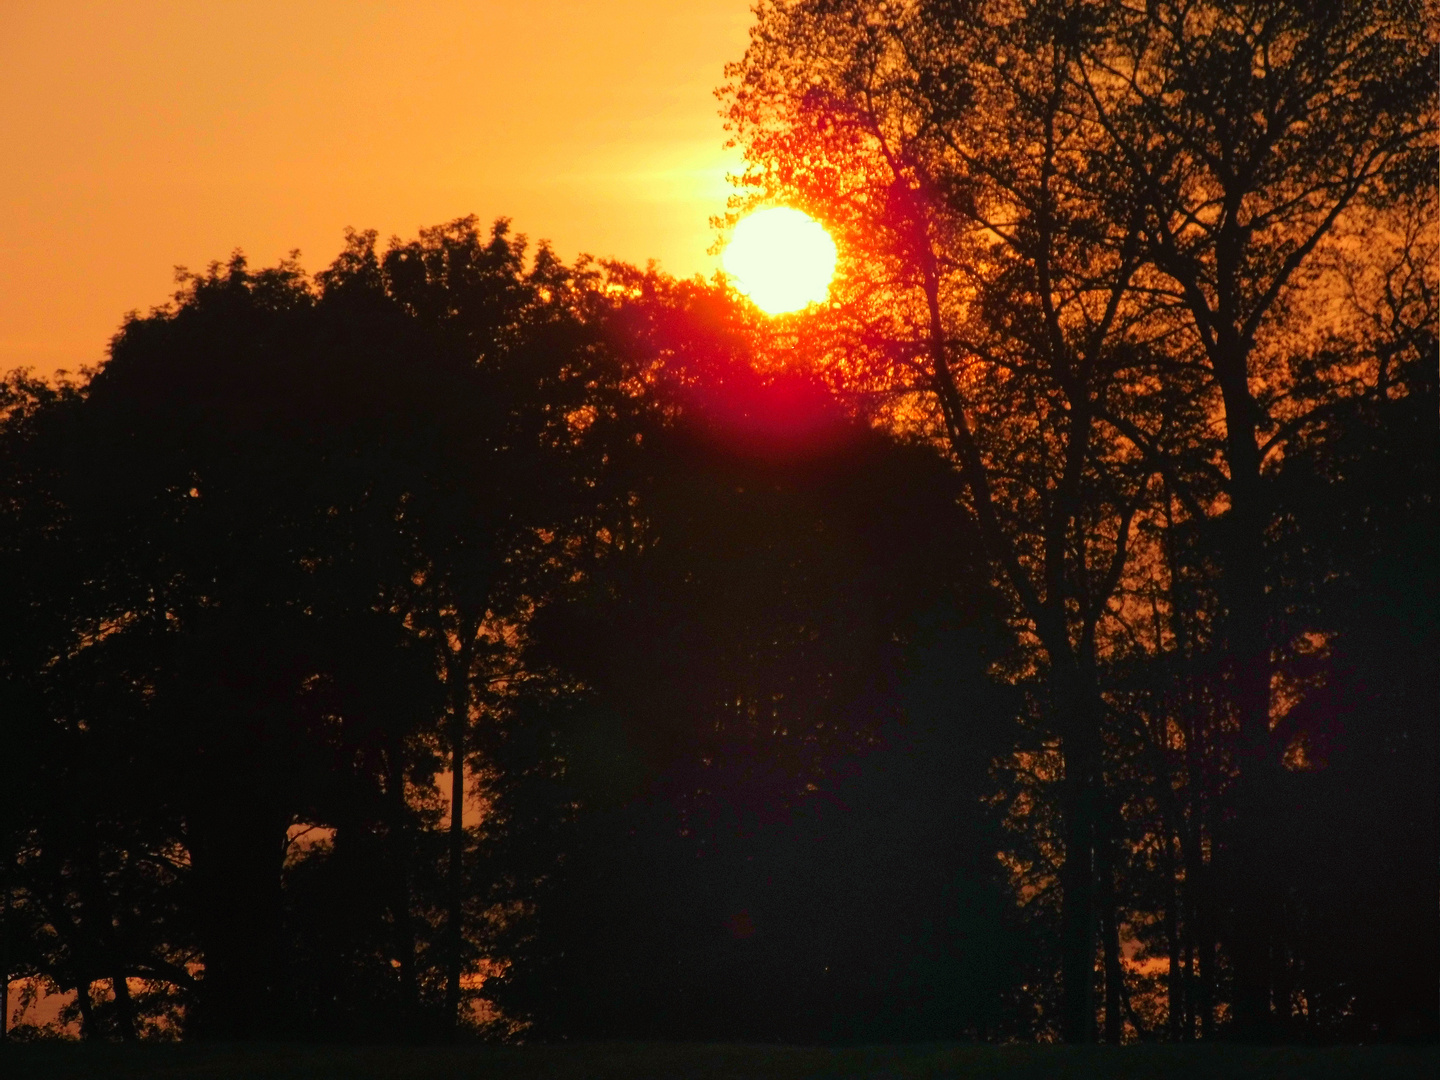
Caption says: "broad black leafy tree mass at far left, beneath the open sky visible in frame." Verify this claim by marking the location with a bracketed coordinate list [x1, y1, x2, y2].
[7, 219, 633, 1038]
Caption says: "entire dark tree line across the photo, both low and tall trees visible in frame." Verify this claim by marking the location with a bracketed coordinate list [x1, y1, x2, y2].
[0, 0, 1440, 1043]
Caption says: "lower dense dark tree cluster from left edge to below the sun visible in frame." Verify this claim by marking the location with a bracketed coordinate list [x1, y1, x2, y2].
[3, 219, 1012, 1038]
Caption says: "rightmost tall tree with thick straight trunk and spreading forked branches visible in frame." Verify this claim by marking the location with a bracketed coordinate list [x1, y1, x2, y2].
[1071, 0, 1437, 1037]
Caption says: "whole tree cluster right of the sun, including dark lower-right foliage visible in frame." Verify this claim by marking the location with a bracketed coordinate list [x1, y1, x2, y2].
[721, 0, 1436, 1041]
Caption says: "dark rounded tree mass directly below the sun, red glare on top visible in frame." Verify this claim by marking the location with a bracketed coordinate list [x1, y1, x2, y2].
[483, 276, 1021, 1041]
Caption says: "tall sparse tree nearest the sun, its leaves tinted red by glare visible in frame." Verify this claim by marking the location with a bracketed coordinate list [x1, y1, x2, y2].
[723, 0, 1165, 1041]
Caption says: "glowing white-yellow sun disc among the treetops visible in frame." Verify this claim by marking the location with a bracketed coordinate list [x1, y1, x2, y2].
[723, 206, 835, 315]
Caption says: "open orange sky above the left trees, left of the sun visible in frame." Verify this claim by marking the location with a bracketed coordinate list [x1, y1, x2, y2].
[0, 0, 750, 373]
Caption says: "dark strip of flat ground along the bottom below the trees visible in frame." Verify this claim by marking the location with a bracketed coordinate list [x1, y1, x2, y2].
[0, 1043, 1440, 1080]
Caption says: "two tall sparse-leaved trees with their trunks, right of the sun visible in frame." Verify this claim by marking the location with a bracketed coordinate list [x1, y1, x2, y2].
[721, 0, 1434, 1040]
